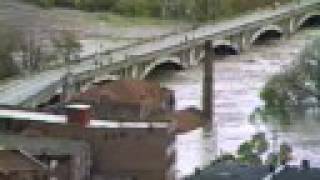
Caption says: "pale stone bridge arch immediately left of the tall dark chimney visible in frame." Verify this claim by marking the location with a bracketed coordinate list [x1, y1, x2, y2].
[139, 57, 187, 79]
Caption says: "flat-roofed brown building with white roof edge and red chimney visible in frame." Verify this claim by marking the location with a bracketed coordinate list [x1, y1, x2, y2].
[0, 105, 175, 180]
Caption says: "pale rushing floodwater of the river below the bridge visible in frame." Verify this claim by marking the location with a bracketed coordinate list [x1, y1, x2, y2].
[150, 31, 320, 177]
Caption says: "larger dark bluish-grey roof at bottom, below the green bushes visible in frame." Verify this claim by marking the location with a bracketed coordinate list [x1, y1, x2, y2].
[186, 162, 269, 180]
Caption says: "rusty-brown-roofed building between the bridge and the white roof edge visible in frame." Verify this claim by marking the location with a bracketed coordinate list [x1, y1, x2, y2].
[73, 82, 175, 121]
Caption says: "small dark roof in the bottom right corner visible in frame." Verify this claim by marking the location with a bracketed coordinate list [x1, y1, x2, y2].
[274, 167, 320, 180]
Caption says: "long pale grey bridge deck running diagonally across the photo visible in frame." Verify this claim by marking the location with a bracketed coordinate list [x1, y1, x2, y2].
[0, 0, 319, 105]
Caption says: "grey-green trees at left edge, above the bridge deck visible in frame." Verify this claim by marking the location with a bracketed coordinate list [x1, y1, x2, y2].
[0, 22, 81, 80]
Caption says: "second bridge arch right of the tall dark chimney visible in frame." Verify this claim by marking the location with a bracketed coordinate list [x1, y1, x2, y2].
[249, 25, 284, 45]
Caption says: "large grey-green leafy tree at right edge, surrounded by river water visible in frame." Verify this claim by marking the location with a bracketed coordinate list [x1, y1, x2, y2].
[260, 37, 320, 110]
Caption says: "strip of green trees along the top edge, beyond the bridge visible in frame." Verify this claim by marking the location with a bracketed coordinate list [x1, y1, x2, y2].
[26, 0, 293, 21]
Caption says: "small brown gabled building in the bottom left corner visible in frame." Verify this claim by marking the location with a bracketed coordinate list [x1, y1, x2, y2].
[0, 149, 47, 180]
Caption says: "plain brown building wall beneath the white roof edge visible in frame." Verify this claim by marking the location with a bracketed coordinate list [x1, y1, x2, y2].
[24, 124, 173, 180]
